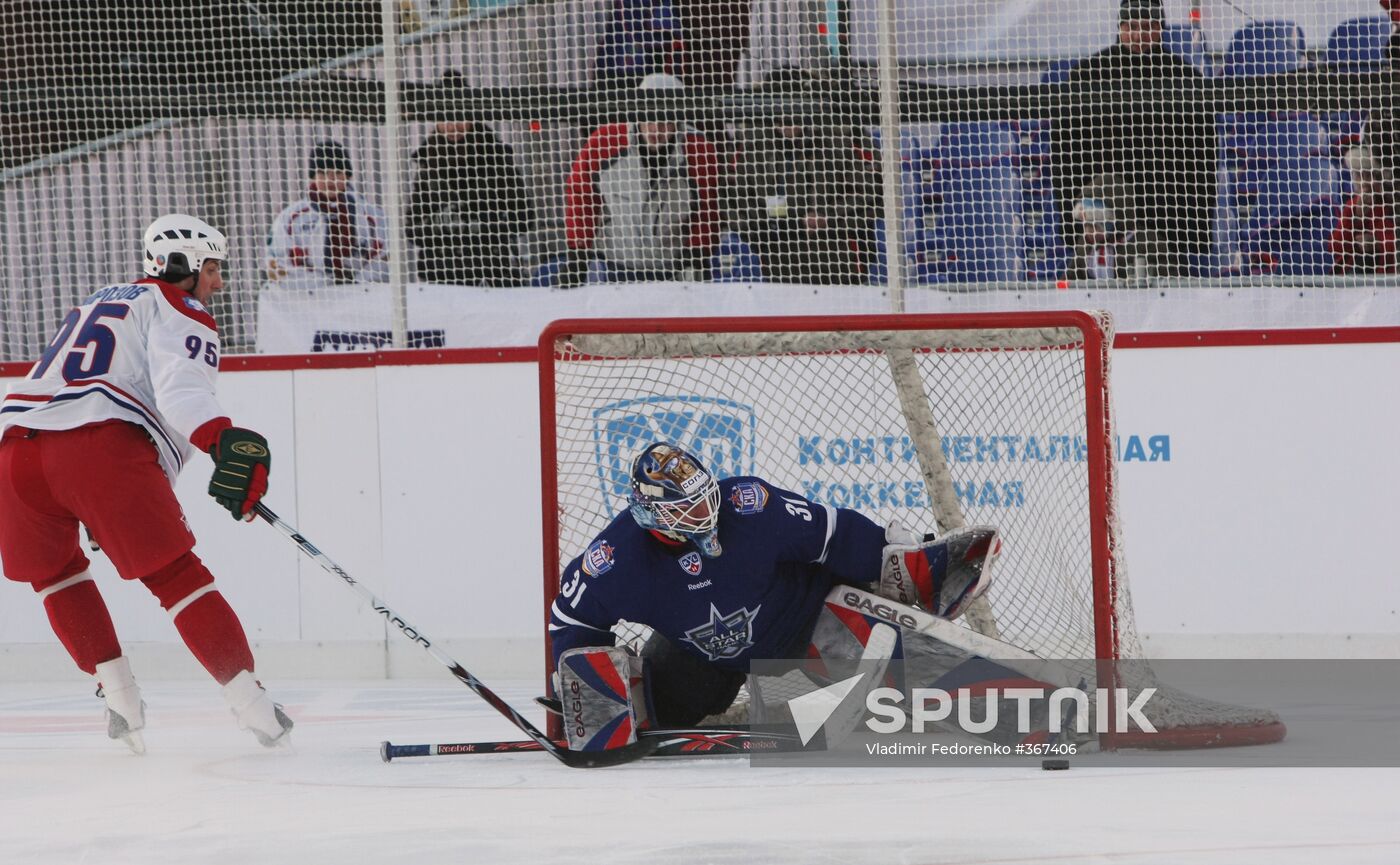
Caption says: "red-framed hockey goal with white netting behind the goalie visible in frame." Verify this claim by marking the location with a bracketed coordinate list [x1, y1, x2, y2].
[539, 312, 1284, 747]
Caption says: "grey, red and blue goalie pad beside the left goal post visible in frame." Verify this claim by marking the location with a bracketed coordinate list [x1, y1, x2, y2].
[559, 647, 647, 750]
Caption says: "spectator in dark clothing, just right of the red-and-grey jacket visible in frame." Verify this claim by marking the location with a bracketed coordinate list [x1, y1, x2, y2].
[731, 69, 881, 284]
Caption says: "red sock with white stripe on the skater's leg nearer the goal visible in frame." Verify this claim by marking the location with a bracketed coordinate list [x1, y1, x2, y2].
[141, 553, 253, 684]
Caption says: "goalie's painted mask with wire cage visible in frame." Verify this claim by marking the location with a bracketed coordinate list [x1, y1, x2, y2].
[627, 441, 721, 558]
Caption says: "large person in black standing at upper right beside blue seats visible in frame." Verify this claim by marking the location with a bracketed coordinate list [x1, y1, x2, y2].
[1051, 0, 1215, 276]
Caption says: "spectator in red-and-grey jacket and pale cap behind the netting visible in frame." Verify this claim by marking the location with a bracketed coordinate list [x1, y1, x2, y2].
[560, 73, 720, 286]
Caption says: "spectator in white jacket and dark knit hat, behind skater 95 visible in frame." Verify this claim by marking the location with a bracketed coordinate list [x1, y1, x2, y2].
[266, 141, 389, 284]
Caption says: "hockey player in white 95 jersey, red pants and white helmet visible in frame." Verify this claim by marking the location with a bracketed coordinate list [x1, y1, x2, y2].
[0, 214, 293, 753]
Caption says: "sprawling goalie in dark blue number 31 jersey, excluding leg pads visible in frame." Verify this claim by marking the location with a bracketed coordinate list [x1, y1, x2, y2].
[549, 442, 1000, 740]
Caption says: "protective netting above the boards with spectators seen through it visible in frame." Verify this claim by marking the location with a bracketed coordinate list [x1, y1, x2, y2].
[0, 0, 1400, 361]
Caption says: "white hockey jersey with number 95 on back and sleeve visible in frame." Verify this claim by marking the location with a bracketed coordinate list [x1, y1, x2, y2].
[0, 279, 224, 483]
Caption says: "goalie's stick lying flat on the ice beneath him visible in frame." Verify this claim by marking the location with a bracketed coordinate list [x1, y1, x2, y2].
[379, 726, 825, 763]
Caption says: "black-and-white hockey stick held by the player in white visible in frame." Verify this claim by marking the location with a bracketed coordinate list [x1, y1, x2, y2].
[253, 502, 657, 768]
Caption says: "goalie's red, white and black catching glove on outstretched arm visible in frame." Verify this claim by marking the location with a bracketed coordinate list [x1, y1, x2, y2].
[879, 523, 1001, 620]
